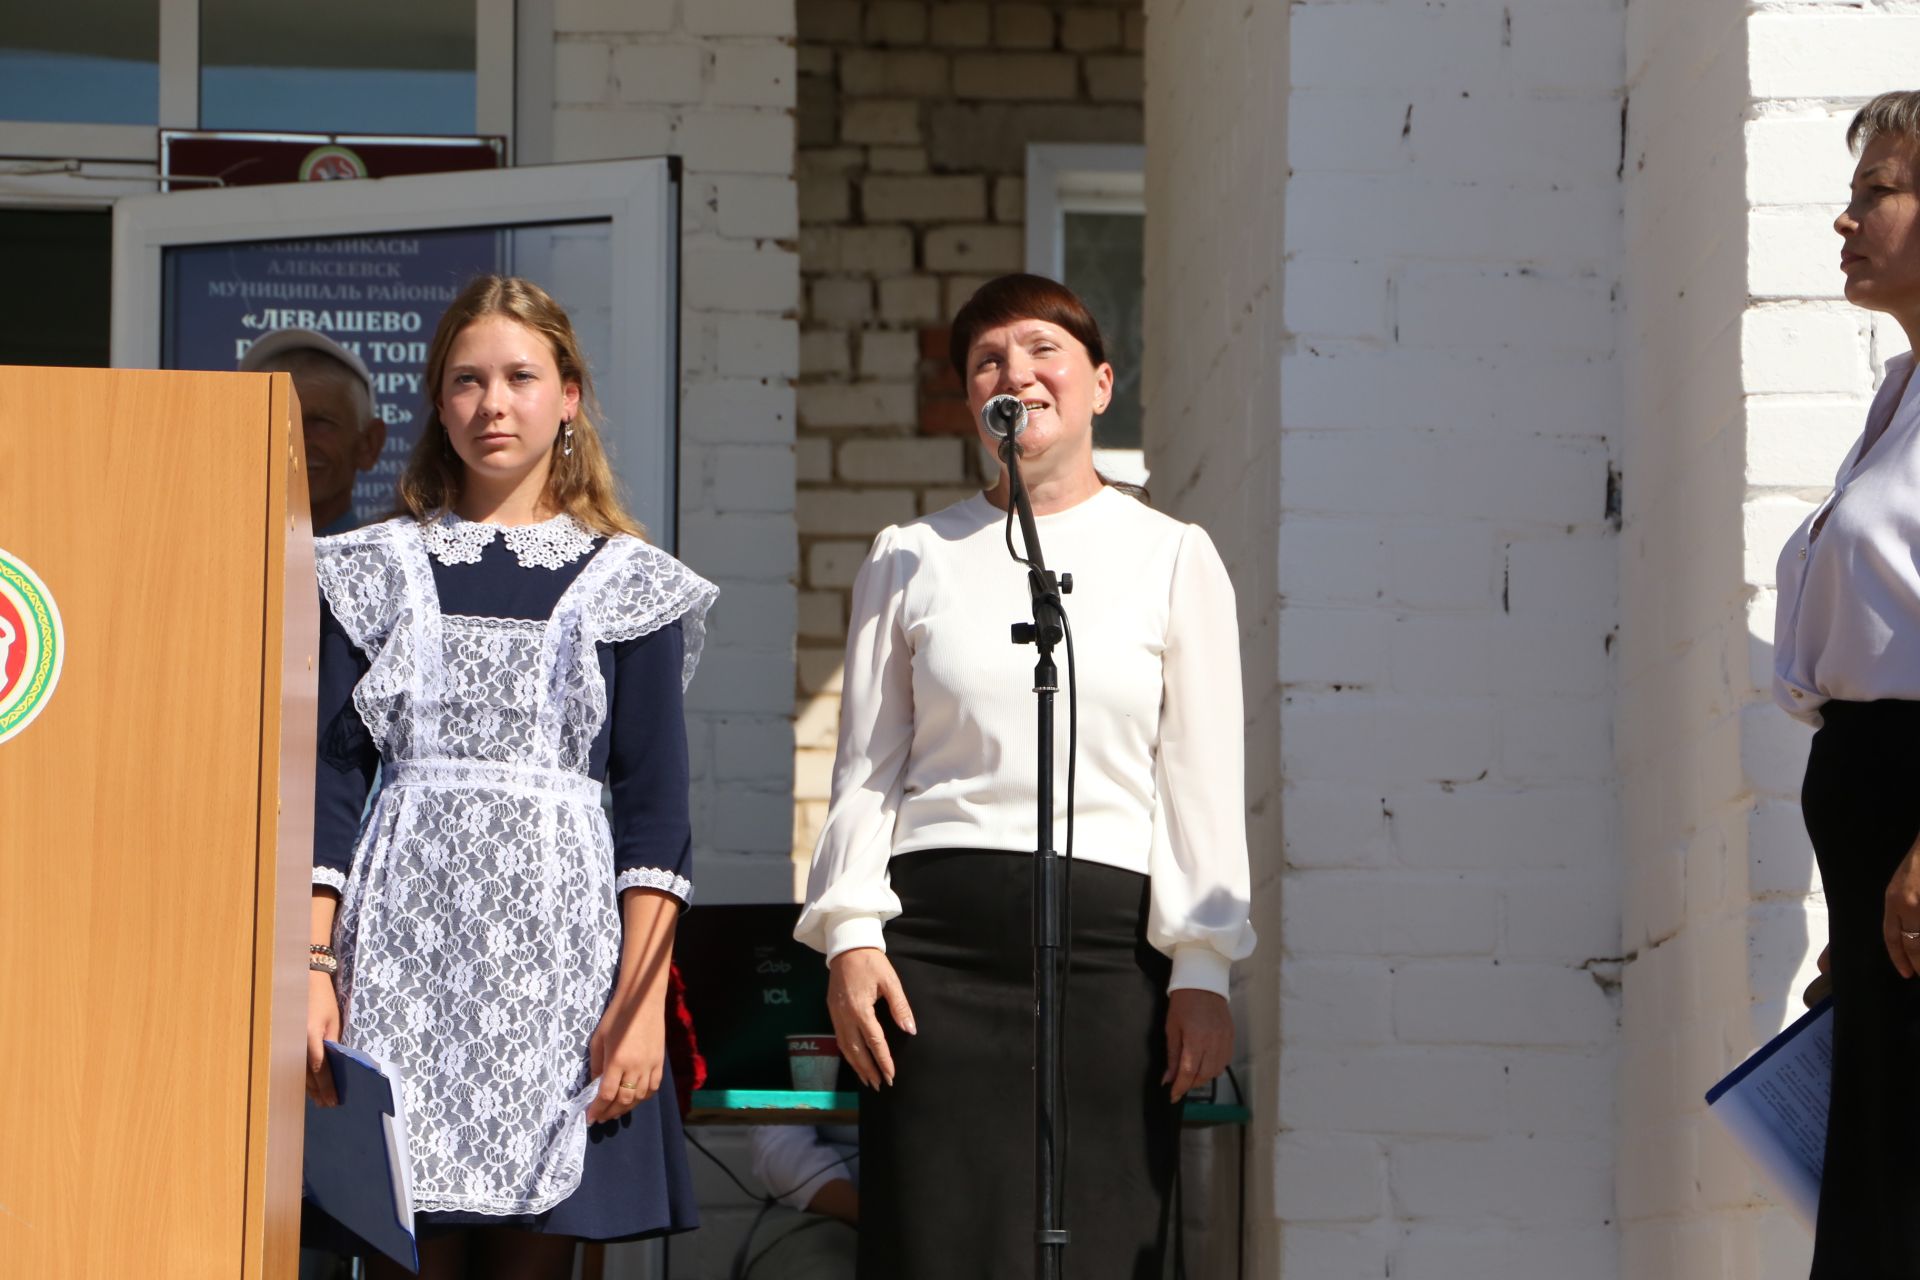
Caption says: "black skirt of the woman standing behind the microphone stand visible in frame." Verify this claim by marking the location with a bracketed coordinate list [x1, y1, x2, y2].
[858, 850, 1179, 1280]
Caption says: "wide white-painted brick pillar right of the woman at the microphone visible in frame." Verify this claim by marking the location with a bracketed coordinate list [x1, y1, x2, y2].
[1146, 0, 1626, 1280]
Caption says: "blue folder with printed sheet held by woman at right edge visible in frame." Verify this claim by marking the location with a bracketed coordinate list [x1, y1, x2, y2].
[1707, 1006, 1834, 1230]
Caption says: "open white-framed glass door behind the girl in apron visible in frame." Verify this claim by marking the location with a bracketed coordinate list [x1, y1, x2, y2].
[111, 159, 680, 549]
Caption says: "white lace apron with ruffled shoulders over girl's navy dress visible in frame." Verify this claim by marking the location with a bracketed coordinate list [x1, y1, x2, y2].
[315, 520, 716, 1215]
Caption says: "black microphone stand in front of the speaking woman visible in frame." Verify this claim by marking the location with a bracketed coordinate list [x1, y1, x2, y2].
[1000, 434, 1073, 1280]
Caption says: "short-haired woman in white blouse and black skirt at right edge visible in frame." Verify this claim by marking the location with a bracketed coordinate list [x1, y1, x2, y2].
[1774, 92, 1920, 1280]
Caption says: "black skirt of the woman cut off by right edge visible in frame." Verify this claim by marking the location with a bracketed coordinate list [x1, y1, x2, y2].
[1801, 700, 1920, 1280]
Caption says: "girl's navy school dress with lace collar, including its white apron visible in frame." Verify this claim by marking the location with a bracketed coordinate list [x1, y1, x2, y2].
[313, 514, 718, 1240]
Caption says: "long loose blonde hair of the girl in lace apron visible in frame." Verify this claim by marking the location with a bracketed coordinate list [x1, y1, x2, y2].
[397, 276, 647, 537]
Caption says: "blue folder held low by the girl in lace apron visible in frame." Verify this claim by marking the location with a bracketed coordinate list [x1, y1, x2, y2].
[301, 1040, 420, 1274]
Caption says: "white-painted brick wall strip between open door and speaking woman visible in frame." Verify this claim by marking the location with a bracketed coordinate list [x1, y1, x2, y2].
[551, 0, 801, 902]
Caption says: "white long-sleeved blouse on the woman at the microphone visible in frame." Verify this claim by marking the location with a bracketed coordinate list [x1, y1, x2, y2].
[795, 489, 1254, 994]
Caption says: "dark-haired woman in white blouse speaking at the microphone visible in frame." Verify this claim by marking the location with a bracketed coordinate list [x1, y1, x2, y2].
[797, 276, 1254, 1280]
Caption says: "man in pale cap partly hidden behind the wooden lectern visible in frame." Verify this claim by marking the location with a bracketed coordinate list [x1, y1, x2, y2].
[240, 328, 386, 537]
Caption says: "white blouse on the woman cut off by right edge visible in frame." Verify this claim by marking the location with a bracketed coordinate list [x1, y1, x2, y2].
[1774, 351, 1920, 725]
